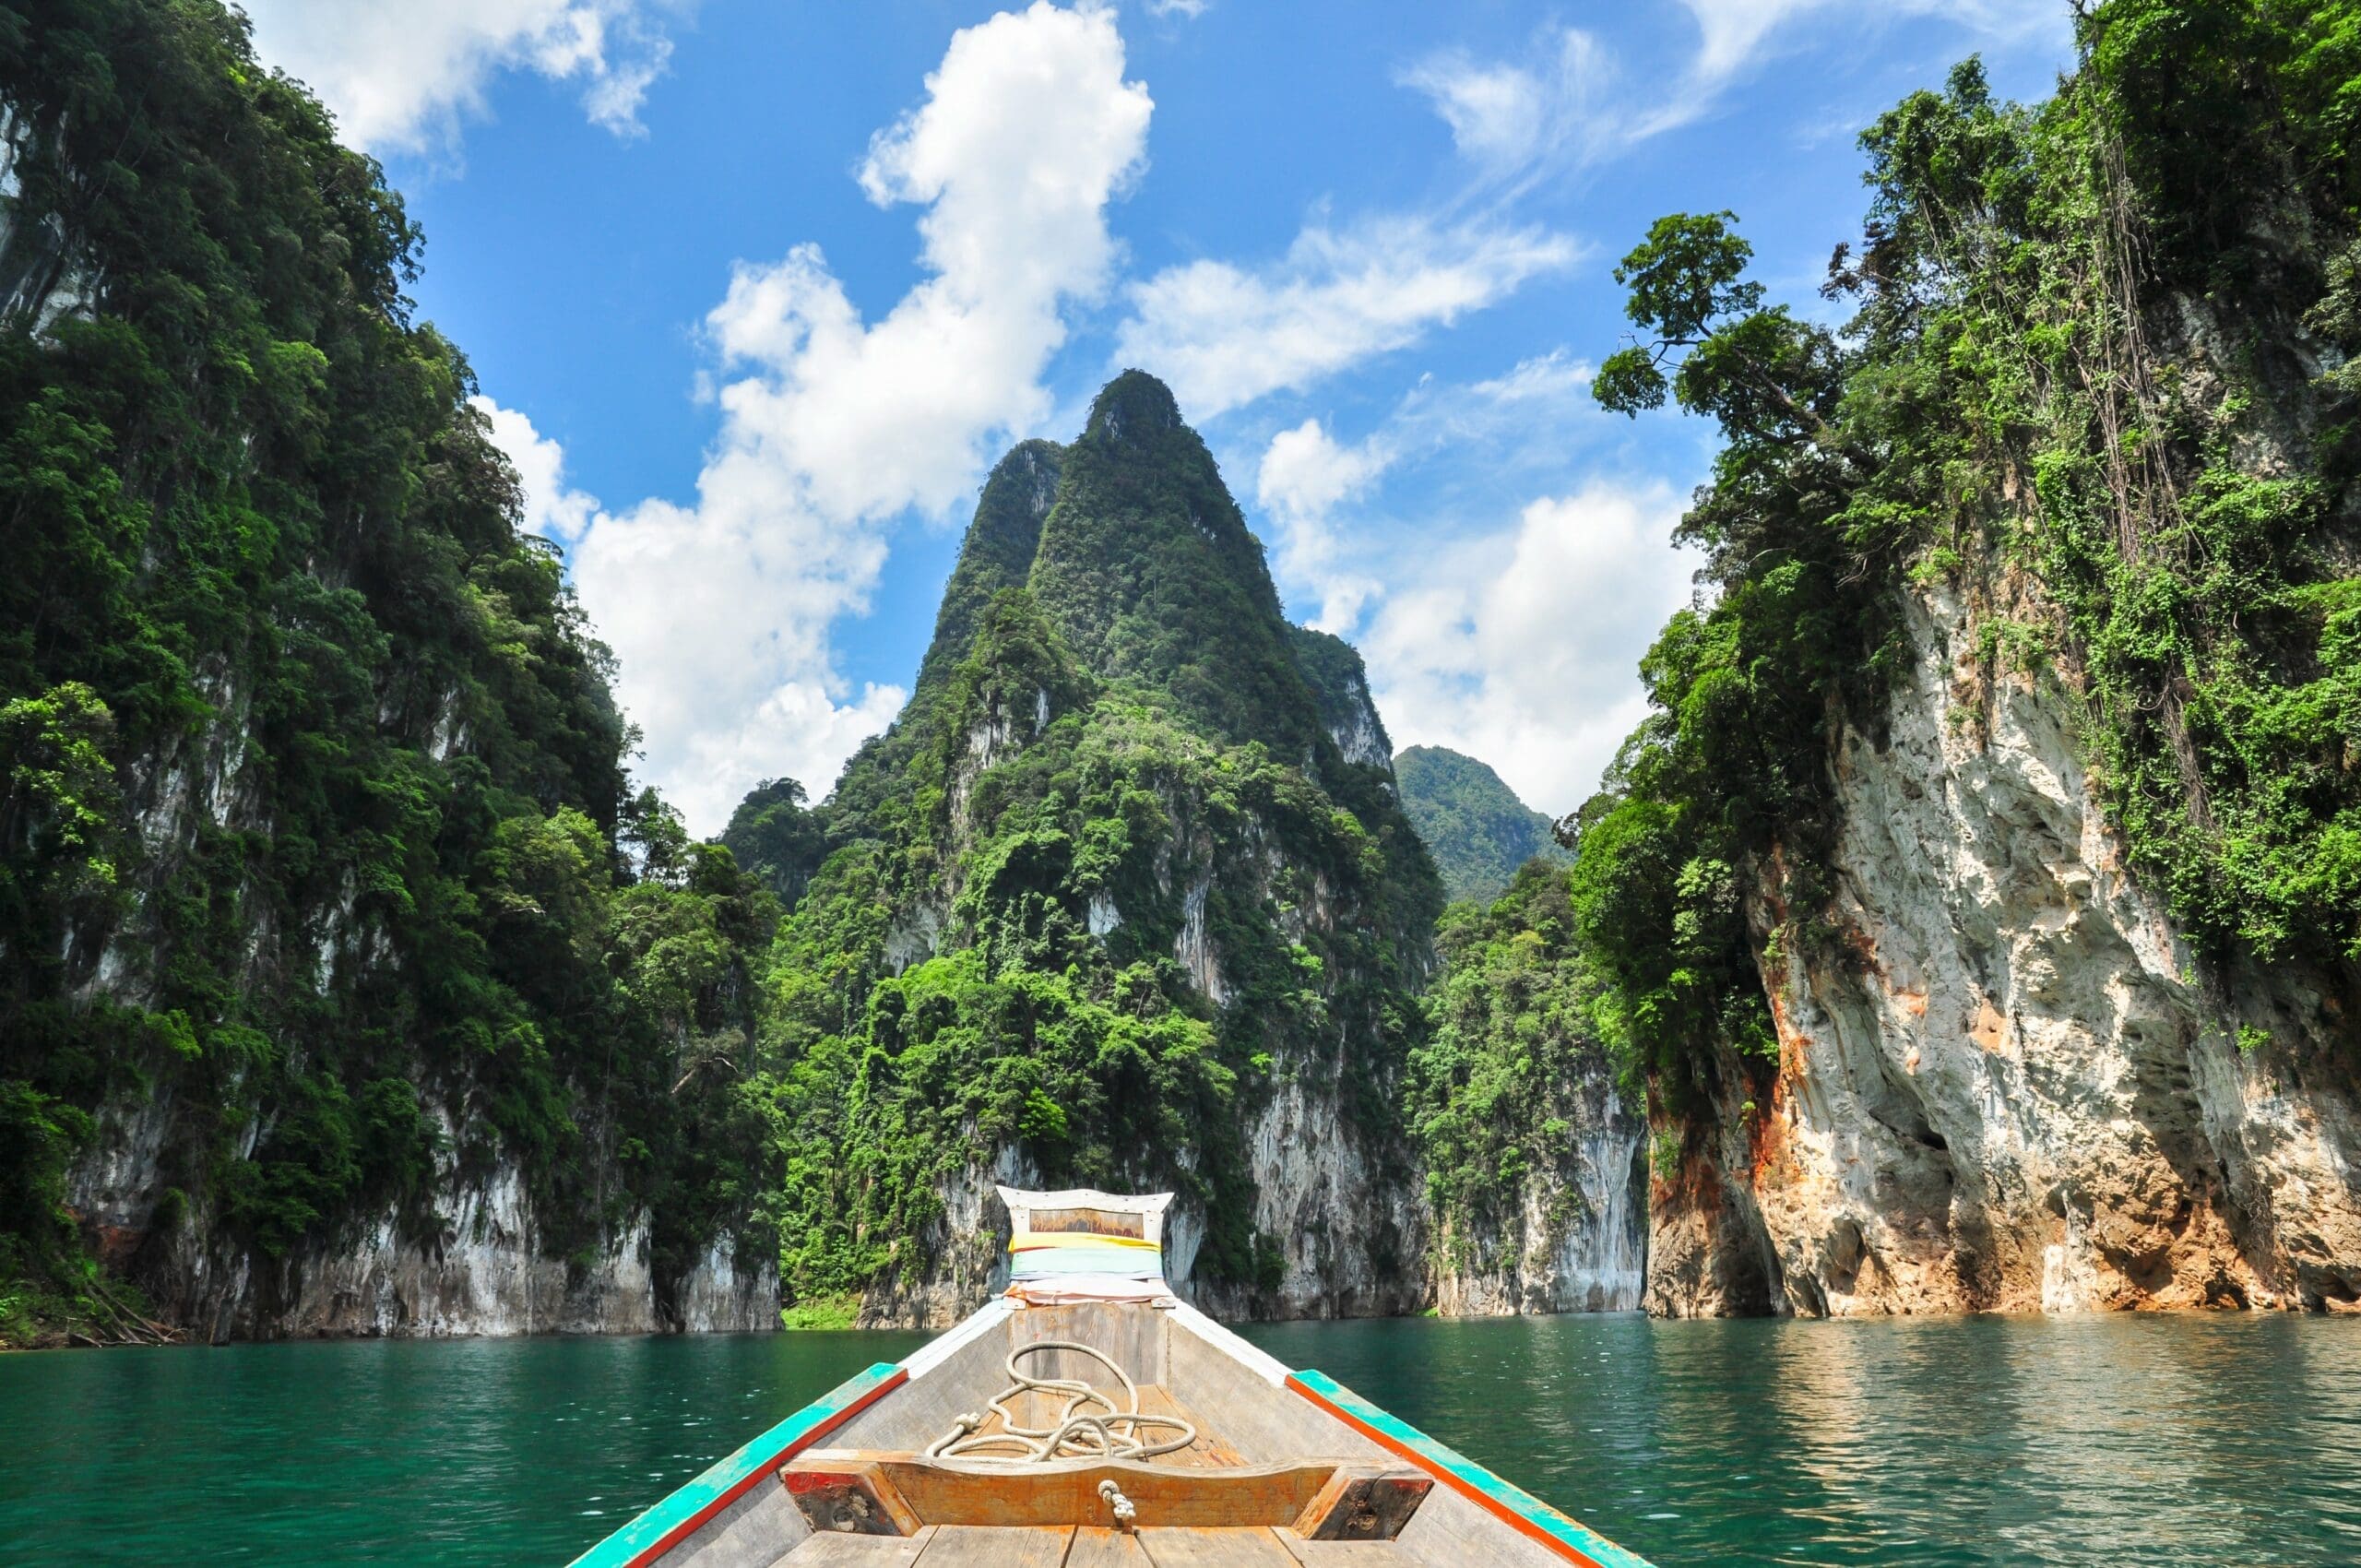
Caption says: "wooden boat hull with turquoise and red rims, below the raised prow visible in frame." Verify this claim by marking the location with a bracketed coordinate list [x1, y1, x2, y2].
[574, 1301, 1648, 1568]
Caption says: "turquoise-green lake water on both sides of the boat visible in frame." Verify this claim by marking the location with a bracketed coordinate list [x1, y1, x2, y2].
[0, 1315, 2361, 1568]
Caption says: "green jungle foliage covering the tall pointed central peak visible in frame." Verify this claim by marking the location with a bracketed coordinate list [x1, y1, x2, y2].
[746, 374, 1442, 1323]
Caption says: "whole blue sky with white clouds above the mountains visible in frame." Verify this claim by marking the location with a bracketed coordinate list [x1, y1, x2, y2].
[248, 0, 2069, 831]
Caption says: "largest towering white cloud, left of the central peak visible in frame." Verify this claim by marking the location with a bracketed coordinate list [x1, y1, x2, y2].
[483, 0, 1152, 831]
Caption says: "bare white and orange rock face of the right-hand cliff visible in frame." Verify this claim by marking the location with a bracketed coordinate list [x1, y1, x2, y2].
[1648, 576, 2361, 1315]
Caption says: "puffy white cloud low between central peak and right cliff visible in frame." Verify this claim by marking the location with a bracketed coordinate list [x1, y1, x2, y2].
[1362, 480, 1695, 814]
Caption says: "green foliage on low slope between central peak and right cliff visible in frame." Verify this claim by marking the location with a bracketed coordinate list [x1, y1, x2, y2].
[1405, 864, 1641, 1264]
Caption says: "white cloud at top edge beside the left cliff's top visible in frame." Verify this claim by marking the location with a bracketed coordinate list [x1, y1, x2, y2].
[243, 0, 673, 153]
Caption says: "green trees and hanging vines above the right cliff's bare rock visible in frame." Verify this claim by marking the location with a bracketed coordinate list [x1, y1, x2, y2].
[1565, 0, 2361, 1112]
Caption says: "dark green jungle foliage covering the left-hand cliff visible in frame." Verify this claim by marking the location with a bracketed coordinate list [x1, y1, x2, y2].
[0, 0, 775, 1336]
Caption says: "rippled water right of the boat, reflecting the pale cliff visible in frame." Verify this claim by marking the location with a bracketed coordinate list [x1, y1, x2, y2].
[1252, 1315, 2361, 1568]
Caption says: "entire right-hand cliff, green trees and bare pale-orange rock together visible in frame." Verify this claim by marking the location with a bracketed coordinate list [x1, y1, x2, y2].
[1494, 0, 2361, 1313]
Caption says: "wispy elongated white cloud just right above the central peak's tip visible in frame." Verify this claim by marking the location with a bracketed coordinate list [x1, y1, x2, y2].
[1117, 215, 1582, 421]
